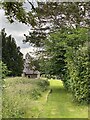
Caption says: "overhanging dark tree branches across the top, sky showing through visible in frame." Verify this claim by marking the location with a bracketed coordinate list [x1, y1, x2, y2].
[2, 0, 90, 46]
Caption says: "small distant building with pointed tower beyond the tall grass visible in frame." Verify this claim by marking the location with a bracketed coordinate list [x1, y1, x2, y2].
[22, 53, 40, 78]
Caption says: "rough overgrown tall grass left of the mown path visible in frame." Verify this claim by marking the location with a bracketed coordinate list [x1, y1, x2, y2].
[2, 77, 49, 118]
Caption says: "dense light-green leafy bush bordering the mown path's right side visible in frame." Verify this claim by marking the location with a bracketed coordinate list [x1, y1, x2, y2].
[64, 43, 90, 103]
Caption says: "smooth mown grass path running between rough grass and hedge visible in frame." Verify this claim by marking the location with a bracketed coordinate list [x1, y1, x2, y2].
[39, 80, 88, 118]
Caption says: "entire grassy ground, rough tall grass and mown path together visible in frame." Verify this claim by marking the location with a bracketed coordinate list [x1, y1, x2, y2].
[2, 77, 88, 118]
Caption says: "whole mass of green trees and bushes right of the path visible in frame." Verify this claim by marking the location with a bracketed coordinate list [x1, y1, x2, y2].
[40, 28, 90, 103]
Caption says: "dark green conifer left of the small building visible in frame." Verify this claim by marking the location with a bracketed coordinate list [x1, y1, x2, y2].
[1, 29, 23, 76]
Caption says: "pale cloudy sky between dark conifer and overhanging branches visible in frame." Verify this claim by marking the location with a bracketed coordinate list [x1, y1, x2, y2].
[0, 0, 35, 58]
